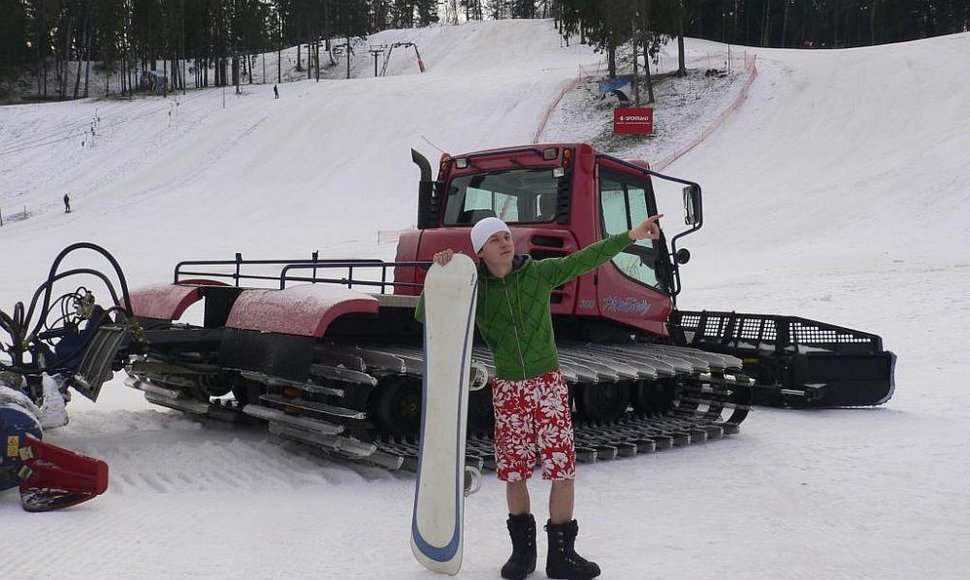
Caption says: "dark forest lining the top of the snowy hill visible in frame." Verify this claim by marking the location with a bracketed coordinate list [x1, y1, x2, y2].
[0, 0, 970, 99]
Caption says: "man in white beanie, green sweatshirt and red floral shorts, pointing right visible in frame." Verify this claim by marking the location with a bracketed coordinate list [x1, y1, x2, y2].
[415, 215, 662, 580]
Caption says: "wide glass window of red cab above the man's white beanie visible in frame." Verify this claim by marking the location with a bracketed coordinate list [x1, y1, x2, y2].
[444, 168, 560, 226]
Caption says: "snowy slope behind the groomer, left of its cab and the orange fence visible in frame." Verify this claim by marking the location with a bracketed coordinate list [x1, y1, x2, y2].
[0, 22, 599, 292]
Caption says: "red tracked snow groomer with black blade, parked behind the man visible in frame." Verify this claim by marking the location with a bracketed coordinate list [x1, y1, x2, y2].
[117, 144, 895, 469]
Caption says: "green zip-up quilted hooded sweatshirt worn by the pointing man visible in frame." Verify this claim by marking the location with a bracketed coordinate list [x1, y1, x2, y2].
[414, 232, 632, 381]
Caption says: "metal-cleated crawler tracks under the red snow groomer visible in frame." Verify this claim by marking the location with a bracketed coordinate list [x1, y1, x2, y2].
[127, 287, 751, 470]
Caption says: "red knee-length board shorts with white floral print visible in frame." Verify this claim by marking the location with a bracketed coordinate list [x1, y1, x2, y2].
[492, 369, 576, 481]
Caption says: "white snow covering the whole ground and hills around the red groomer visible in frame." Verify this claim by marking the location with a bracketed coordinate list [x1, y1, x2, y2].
[0, 21, 970, 580]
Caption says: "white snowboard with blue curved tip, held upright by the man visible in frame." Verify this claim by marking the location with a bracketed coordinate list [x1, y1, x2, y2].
[411, 254, 478, 574]
